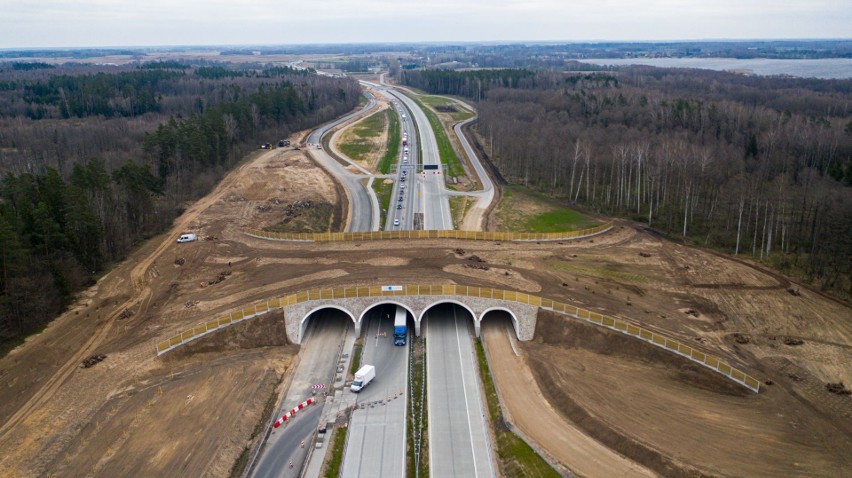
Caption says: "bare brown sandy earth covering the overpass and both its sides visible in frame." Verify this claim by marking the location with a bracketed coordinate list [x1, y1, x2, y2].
[0, 129, 852, 476]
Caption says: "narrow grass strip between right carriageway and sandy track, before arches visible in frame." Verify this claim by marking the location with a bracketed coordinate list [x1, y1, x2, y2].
[476, 339, 559, 477]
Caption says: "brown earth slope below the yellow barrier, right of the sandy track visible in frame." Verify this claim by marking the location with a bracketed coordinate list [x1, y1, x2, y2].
[522, 312, 852, 476]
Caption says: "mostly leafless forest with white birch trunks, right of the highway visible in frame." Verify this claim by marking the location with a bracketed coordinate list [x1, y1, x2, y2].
[400, 67, 852, 296]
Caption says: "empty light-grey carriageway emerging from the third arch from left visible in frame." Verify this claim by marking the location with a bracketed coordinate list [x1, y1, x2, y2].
[423, 304, 495, 477]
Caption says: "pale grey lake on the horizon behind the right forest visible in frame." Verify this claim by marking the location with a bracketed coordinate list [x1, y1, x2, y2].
[579, 58, 852, 79]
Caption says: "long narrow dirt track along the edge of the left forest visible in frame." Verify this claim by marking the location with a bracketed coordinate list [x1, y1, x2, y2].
[0, 150, 274, 440]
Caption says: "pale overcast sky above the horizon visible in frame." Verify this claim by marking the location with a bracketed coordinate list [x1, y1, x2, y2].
[0, 0, 852, 48]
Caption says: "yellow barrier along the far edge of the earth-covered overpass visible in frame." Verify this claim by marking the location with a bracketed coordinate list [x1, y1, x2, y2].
[244, 222, 613, 242]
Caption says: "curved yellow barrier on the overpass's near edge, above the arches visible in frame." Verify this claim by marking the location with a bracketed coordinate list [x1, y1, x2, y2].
[157, 284, 760, 392]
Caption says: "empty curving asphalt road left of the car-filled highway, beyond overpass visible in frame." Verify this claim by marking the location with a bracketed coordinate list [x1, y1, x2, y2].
[307, 93, 376, 232]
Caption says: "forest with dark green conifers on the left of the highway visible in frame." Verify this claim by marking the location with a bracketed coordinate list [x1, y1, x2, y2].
[0, 62, 360, 353]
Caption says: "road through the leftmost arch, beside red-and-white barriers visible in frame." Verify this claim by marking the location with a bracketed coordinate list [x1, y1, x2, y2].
[252, 310, 354, 478]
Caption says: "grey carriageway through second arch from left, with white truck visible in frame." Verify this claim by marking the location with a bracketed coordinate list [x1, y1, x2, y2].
[341, 308, 408, 478]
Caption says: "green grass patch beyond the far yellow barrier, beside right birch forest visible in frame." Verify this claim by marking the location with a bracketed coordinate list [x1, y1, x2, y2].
[497, 186, 599, 232]
